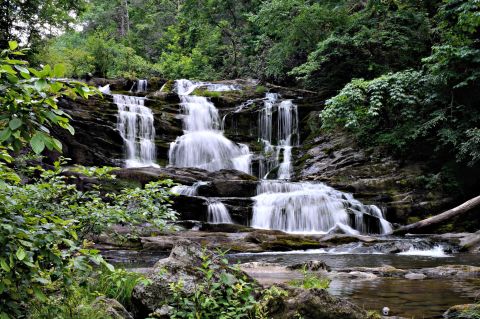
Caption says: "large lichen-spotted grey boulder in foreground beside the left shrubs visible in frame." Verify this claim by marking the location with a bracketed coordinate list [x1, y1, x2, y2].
[132, 240, 253, 316]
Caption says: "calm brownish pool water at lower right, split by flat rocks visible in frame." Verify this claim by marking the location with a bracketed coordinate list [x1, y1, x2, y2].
[230, 251, 480, 319]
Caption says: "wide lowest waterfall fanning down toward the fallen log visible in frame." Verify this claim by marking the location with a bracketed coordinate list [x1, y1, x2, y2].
[251, 180, 391, 234]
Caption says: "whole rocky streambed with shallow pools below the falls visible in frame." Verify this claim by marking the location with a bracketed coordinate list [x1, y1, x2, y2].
[99, 222, 480, 318]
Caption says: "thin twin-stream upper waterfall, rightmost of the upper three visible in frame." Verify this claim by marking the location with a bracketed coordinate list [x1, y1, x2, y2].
[258, 93, 298, 180]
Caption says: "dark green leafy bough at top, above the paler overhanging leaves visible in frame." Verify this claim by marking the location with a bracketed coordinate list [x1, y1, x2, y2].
[290, 4, 430, 91]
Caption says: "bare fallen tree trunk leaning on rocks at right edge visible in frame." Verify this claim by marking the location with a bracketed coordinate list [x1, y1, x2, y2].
[393, 196, 480, 235]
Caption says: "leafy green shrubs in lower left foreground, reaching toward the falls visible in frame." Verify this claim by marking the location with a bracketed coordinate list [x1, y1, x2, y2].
[0, 164, 175, 316]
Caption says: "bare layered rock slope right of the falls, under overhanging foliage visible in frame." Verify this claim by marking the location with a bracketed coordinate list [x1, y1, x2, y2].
[295, 132, 455, 223]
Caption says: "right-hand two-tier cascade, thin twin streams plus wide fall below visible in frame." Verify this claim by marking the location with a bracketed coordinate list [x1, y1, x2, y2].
[251, 93, 392, 234]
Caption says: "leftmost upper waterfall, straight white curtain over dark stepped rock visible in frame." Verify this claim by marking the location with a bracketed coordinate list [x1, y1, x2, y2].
[113, 94, 158, 167]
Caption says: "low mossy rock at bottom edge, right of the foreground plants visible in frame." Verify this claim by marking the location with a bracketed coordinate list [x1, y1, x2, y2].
[269, 286, 368, 319]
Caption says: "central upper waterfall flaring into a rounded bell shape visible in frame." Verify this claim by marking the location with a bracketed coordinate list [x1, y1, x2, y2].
[169, 80, 251, 173]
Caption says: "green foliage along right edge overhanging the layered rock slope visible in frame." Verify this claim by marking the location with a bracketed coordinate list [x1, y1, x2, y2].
[321, 0, 480, 176]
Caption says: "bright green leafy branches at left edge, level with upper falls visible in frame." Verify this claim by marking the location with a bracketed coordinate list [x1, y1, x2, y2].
[0, 41, 96, 154]
